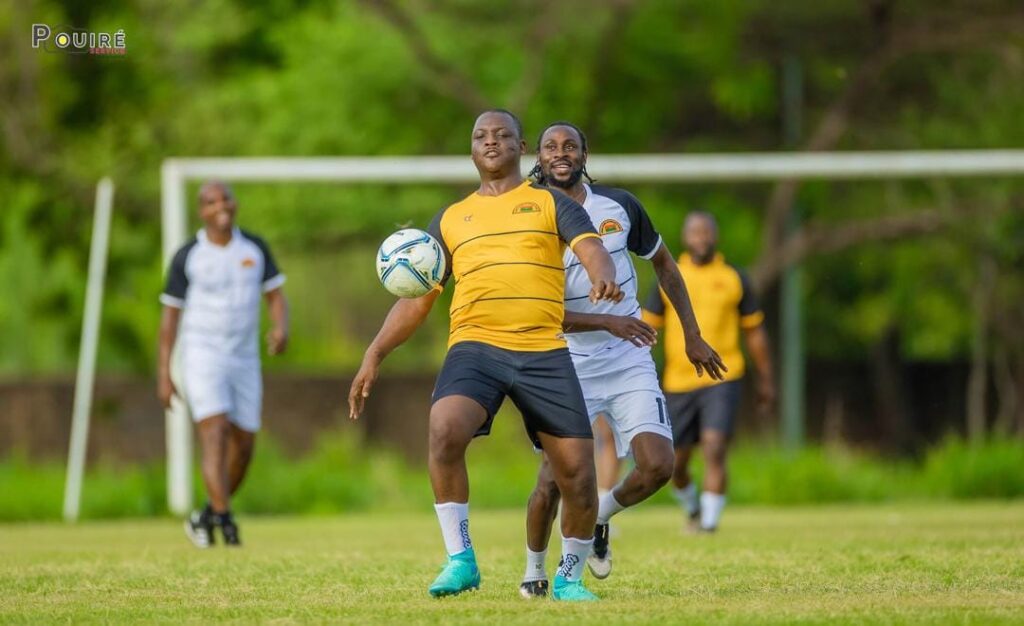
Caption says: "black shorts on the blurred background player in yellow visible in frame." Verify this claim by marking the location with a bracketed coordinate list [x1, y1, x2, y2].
[665, 380, 742, 448]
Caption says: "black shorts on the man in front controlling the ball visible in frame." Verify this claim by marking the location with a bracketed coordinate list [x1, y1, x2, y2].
[432, 341, 594, 448]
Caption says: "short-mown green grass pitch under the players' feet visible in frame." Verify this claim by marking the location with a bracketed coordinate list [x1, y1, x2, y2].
[0, 502, 1024, 626]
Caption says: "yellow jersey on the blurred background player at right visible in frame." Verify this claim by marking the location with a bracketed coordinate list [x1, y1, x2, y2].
[643, 254, 764, 393]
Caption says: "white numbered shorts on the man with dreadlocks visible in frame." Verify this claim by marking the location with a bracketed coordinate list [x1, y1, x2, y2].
[580, 359, 672, 458]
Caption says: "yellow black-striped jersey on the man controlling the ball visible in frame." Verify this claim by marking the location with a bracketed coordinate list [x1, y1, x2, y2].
[427, 180, 597, 351]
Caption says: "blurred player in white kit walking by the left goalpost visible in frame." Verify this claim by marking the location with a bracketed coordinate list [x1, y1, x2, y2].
[158, 182, 288, 548]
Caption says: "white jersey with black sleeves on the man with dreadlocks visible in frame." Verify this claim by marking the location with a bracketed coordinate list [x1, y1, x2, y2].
[563, 184, 662, 381]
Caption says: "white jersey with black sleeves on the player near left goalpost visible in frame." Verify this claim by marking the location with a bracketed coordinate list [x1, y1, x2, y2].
[160, 228, 285, 360]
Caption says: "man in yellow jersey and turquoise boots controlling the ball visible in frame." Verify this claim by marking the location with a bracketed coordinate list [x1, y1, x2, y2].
[348, 110, 622, 600]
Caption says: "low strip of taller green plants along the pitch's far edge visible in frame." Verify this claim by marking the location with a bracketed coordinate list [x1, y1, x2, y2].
[0, 434, 1024, 520]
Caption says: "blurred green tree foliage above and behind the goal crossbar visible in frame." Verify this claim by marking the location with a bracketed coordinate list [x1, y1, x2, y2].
[0, 0, 1024, 375]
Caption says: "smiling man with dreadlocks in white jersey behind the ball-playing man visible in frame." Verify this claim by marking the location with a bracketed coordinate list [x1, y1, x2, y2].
[519, 122, 725, 597]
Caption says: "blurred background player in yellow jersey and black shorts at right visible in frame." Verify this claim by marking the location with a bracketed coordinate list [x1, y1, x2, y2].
[644, 212, 775, 533]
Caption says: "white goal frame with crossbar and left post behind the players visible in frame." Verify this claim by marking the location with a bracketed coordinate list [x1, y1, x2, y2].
[161, 150, 1024, 515]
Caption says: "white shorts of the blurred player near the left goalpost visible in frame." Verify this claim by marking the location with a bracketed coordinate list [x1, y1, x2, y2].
[181, 350, 263, 432]
